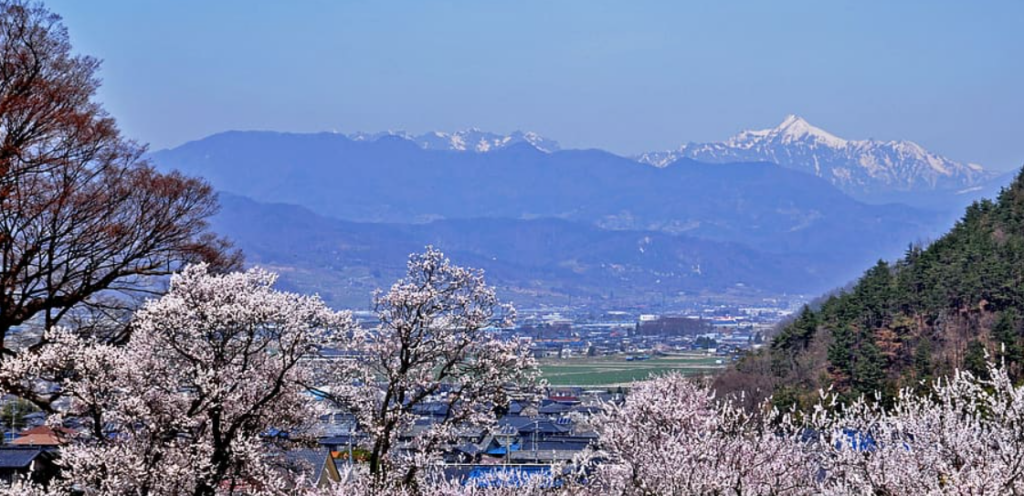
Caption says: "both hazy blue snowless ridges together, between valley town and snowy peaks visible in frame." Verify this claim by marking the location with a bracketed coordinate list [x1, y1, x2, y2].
[152, 131, 966, 301]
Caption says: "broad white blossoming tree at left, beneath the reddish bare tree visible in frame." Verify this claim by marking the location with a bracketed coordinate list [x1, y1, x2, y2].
[0, 264, 351, 496]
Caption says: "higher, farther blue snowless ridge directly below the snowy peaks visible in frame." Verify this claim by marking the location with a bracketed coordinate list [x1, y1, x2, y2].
[153, 132, 945, 274]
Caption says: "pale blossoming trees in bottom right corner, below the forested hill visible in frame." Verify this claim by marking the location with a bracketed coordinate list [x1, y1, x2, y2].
[813, 364, 1024, 495]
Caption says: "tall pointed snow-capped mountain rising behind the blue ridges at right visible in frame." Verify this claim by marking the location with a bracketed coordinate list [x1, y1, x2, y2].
[638, 115, 994, 200]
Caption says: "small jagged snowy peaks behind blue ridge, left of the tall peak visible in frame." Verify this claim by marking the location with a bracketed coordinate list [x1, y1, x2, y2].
[348, 128, 561, 153]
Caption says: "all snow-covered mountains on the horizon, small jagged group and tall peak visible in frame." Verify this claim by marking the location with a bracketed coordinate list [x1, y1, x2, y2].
[331, 115, 1010, 211]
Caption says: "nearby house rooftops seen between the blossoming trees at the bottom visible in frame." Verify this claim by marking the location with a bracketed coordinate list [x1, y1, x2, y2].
[0, 387, 610, 487]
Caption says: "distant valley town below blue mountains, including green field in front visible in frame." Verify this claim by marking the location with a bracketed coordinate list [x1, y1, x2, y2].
[355, 297, 805, 389]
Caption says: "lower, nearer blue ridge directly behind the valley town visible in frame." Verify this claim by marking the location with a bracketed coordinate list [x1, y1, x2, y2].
[213, 193, 837, 307]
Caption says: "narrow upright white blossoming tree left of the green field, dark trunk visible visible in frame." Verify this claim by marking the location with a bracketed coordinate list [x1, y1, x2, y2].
[319, 247, 537, 485]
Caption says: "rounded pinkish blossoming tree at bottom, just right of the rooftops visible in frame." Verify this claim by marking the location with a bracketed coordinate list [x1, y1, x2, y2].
[589, 373, 815, 495]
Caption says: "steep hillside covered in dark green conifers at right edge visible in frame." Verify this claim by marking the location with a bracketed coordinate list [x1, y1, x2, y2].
[719, 168, 1024, 406]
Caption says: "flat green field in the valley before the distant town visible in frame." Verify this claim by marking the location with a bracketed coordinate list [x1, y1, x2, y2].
[541, 355, 728, 386]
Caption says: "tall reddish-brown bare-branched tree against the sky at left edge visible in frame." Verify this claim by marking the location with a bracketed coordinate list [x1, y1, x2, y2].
[0, 0, 241, 406]
